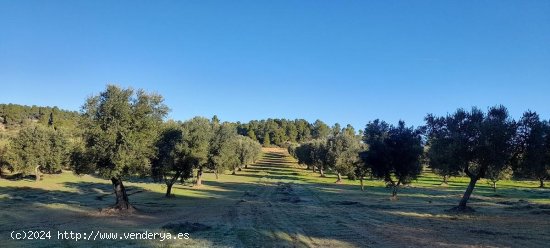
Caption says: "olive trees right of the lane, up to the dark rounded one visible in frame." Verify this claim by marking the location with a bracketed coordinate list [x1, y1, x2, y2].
[288, 120, 423, 196]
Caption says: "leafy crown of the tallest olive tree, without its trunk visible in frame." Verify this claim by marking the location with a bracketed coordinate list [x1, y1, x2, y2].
[74, 85, 168, 178]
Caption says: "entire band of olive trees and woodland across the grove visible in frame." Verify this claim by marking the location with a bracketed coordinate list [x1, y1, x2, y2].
[0, 85, 550, 210]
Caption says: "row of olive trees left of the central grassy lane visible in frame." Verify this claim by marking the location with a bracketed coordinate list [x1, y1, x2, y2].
[0, 85, 261, 210]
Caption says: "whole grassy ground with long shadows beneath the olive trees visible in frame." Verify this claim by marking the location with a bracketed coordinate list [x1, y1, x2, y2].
[0, 148, 550, 247]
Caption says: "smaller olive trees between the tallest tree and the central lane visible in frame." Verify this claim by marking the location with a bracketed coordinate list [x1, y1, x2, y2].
[152, 117, 261, 197]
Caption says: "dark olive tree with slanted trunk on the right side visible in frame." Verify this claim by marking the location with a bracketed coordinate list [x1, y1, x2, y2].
[426, 106, 516, 211]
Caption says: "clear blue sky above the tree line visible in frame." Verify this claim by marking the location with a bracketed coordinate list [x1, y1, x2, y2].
[0, 0, 550, 128]
